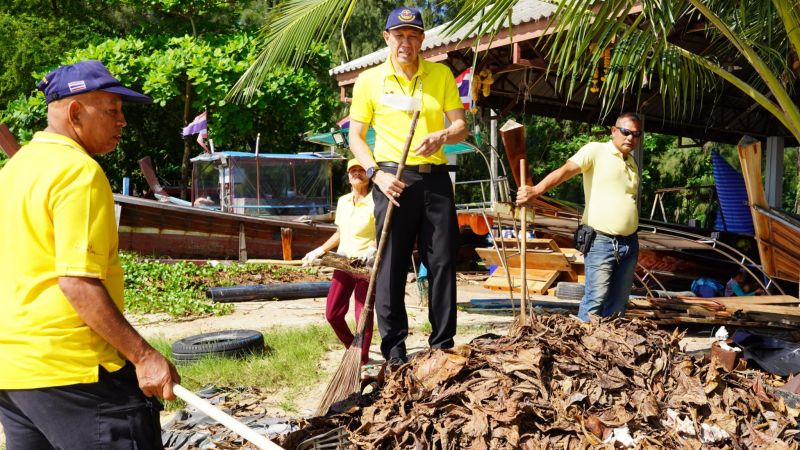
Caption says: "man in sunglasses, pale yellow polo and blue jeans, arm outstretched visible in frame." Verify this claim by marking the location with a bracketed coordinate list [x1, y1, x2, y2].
[517, 113, 642, 322]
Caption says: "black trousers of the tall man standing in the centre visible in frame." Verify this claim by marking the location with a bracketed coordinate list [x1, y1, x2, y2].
[372, 170, 458, 360]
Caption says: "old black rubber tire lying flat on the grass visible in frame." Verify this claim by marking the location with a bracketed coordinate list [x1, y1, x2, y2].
[172, 330, 264, 363]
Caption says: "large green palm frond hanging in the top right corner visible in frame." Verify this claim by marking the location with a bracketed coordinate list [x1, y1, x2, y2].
[540, 0, 800, 139]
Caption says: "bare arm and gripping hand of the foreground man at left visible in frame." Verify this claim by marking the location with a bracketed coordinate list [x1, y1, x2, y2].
[58, 277, 181, 400]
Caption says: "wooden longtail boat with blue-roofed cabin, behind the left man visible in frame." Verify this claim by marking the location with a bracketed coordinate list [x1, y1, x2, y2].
[114, 152, 342, 261]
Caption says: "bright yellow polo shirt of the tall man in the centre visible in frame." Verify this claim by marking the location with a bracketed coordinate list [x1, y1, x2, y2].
[350, 56, 464, 166]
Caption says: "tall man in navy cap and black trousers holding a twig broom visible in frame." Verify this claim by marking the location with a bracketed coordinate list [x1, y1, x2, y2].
[350, 7, 467, 368]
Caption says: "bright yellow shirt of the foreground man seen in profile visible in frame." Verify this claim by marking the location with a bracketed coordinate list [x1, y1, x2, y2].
[0, 132, 125, 389]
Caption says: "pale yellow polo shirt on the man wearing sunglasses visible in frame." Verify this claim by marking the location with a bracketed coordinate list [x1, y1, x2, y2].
[569, 141, 639, 236]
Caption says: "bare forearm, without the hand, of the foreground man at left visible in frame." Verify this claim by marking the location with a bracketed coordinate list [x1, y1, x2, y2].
[58, 277, 155, 365]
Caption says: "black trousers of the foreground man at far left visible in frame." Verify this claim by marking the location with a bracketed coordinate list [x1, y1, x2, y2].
[0, 363, 164, 450]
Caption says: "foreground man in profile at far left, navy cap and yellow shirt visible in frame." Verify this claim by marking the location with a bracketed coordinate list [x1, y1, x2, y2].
[0, 61, 179, 450]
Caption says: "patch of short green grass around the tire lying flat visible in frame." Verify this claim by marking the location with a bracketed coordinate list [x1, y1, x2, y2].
[151, 324, 341, 411]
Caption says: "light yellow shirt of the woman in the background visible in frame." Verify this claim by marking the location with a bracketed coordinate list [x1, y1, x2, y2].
[336, 192, 375, 258]
